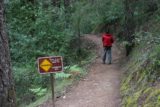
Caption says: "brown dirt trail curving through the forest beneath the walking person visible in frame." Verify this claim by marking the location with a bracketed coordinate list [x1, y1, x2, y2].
[40, 35, 123, 107]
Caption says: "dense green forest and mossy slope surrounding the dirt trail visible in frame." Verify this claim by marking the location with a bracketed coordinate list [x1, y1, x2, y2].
[0, 0, 160, 107]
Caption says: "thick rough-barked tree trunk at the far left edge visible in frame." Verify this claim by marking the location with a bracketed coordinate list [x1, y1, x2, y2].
[0, 0, 16, 107]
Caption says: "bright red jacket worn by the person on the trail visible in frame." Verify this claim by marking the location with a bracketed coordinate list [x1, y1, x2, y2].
[102, 34, 114, 46]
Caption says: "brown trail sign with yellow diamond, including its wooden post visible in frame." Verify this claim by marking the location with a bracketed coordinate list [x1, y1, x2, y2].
[38, 56, 63, 107]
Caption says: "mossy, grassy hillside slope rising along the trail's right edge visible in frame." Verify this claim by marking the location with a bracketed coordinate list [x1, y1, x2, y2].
[121, 17, 160, 107]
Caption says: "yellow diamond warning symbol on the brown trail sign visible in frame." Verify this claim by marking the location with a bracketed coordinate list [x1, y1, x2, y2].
[40, 59, 53, 72]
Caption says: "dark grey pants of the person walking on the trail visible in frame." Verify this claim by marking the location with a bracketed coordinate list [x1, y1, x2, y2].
[103, 47, 112, 64]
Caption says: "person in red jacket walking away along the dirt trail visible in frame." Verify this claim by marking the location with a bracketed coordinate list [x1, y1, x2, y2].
[102, 33, 114, 64]
